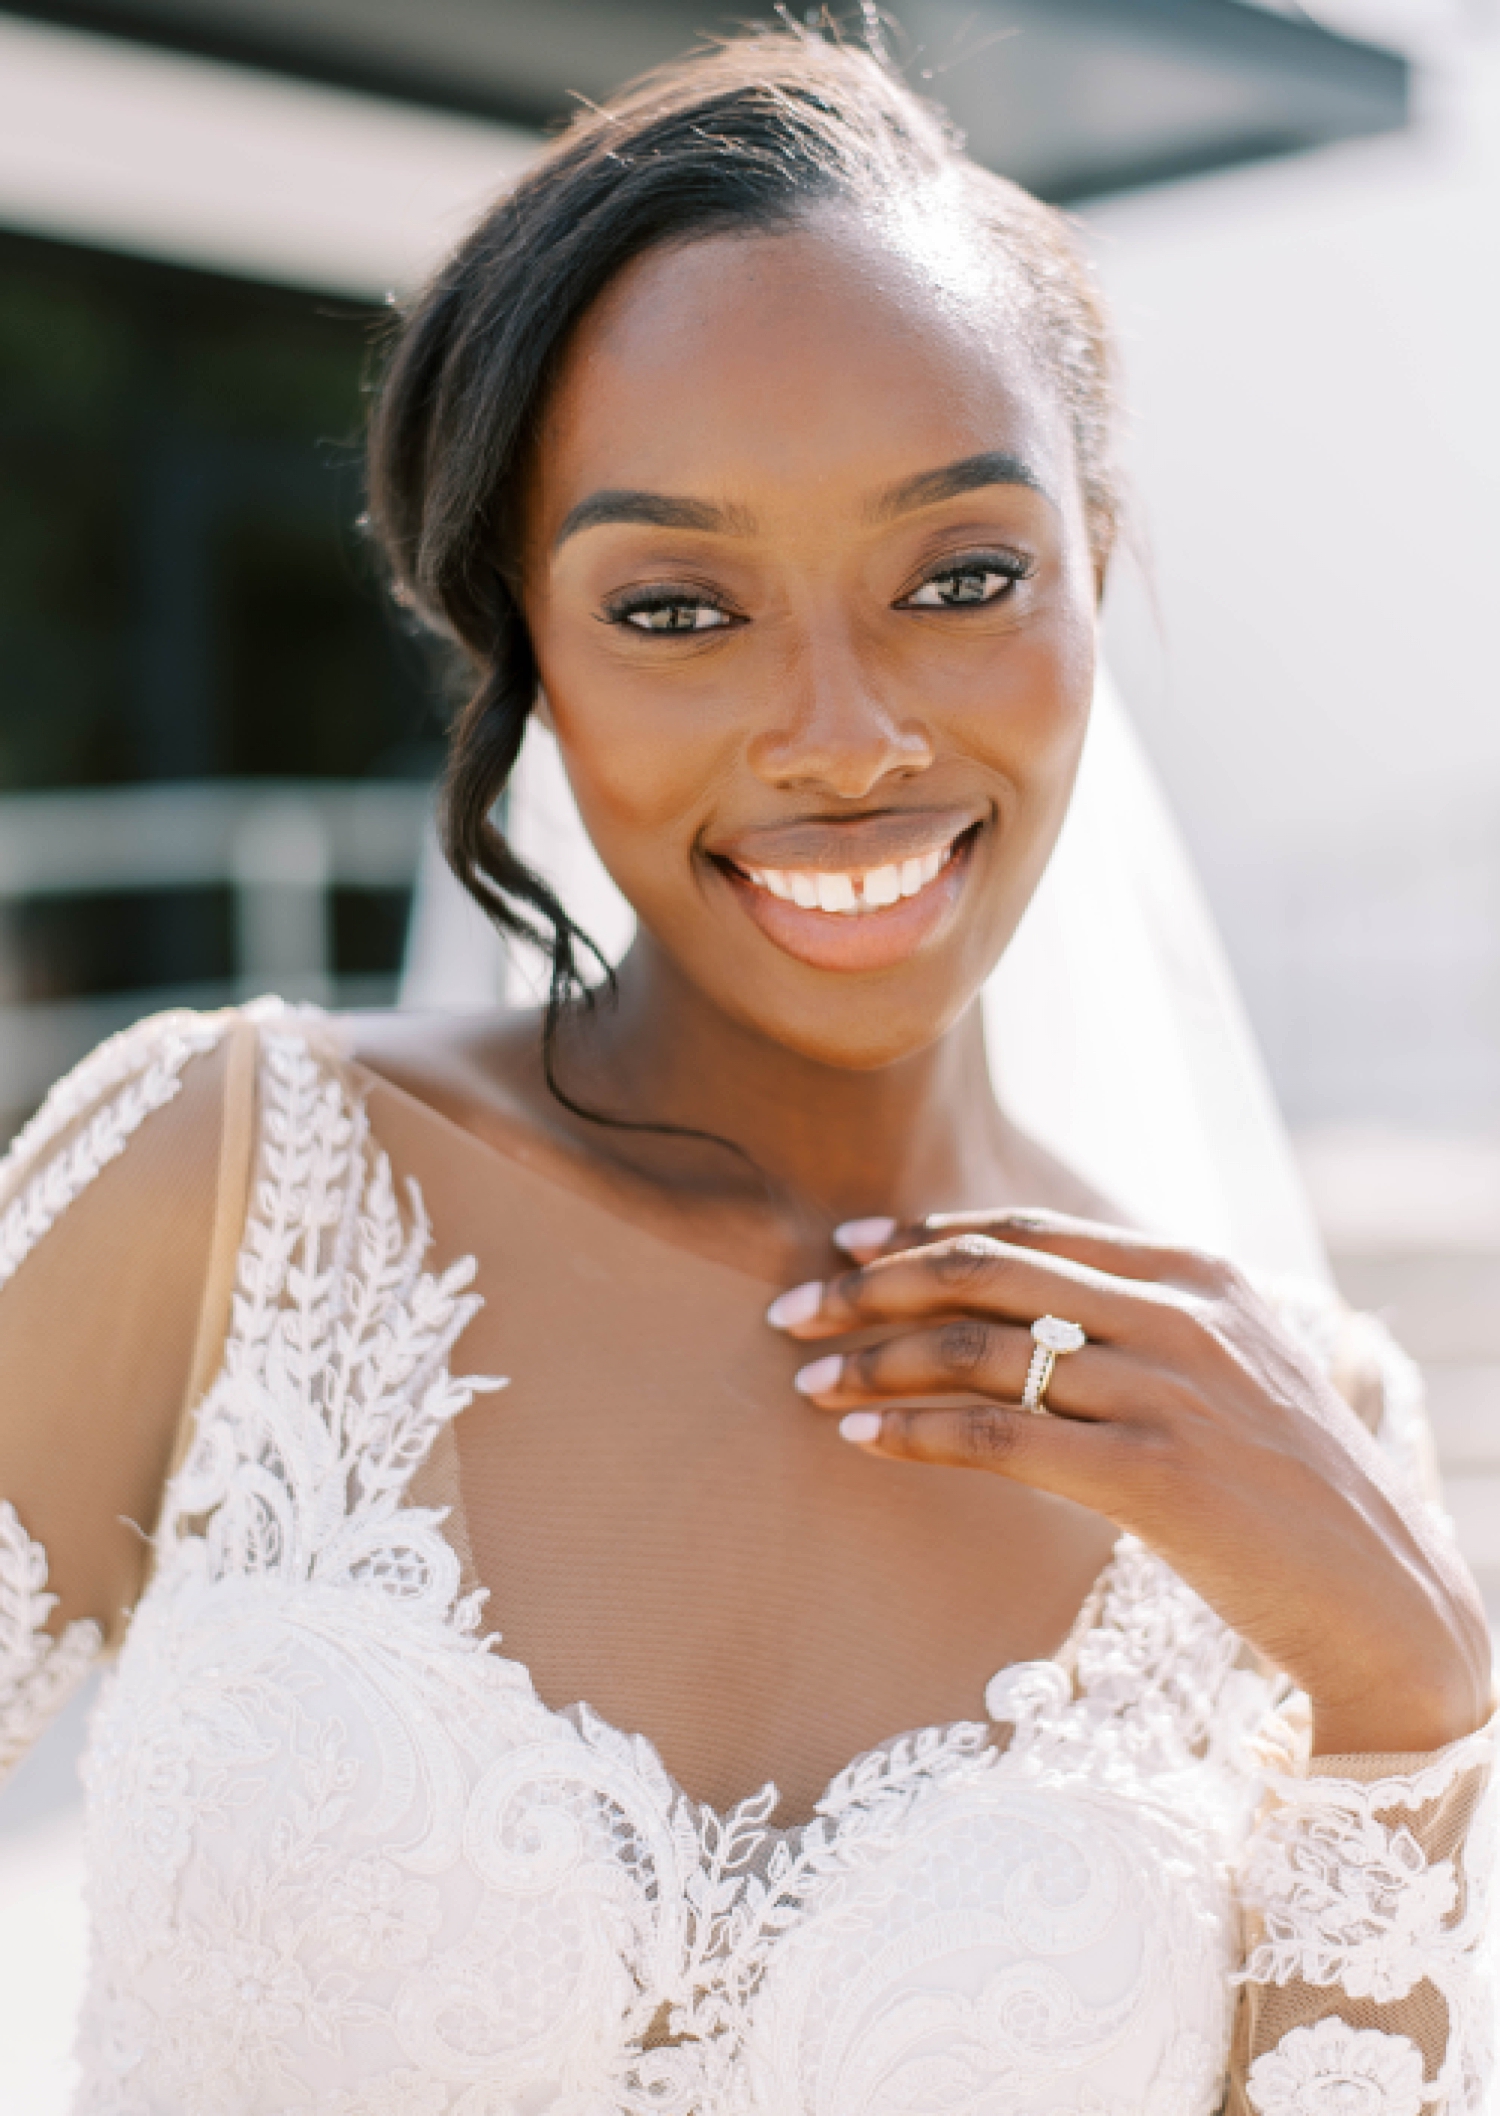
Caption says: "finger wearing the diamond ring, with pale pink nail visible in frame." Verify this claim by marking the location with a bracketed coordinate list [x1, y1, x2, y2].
[795, 1316, 1125, 1418]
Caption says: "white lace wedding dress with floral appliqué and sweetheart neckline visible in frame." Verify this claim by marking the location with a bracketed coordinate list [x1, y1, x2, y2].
[0, 1007, 1496, 2116]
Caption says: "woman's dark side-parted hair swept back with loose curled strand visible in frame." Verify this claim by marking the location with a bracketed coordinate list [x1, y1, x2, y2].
[370, 28, 1117, 1115]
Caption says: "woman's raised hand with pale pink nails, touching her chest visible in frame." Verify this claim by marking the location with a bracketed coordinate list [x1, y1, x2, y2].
[770, 1212, 1489, 1754]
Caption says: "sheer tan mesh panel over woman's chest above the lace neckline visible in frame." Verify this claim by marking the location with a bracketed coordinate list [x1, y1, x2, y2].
[410, 1142, 1115, 1820]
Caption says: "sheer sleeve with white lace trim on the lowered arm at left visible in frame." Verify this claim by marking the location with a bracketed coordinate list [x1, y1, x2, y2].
[0, 1014, 224, 1777]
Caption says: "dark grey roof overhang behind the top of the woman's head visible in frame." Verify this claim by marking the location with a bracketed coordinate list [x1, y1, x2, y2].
[6, 0, 1409, 199]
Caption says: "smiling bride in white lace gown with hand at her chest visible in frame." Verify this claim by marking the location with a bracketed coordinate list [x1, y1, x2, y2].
[0, 30, 1494, 2116]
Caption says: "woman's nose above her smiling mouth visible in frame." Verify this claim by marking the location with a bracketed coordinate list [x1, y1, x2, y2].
[749, 635, 933, 800]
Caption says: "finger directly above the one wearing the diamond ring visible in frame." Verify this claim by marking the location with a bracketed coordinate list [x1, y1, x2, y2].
[766, 1234, 1183, 1344]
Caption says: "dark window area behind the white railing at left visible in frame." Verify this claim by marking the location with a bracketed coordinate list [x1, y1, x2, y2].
[0, 233, 442, 1132]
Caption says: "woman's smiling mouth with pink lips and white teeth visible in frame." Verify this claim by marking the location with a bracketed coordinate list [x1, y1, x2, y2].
[713, 817, 977, 971]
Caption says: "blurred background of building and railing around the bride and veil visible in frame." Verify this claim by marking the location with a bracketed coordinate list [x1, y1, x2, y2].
[0, 0, 1500, 2116]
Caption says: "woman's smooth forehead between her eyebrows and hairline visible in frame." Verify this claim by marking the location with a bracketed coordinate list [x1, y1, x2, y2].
[535, 216, 1071, 518]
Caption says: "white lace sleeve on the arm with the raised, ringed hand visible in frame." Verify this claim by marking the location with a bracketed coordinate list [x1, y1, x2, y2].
[1227, 1316, 1500, 2116]
